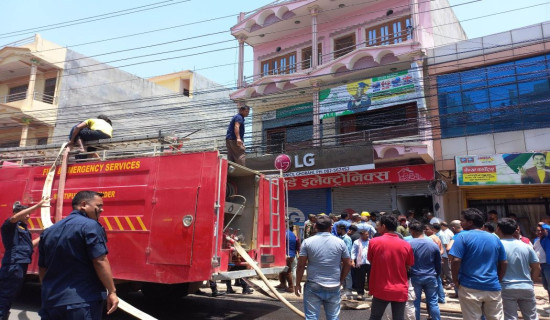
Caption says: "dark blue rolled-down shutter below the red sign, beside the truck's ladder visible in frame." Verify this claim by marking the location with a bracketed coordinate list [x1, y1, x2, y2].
[288, 188, 332, 224]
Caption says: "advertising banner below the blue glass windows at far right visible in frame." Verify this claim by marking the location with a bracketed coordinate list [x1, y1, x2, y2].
[455, 151, 550, 186]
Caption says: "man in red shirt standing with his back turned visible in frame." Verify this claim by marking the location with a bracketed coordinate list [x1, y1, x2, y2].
[367, 216, 414, 320]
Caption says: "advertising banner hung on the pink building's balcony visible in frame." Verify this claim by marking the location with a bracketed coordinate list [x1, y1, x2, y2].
[319, 70, 417, 119]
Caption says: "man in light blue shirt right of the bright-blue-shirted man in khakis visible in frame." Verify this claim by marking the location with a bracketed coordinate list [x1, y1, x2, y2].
[497, 218, 540, 320]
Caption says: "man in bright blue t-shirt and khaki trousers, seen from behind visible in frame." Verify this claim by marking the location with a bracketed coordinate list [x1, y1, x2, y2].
[449, 208, 506, 320]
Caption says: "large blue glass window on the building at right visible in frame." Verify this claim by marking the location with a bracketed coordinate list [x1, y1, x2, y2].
[437, 55, 550, 138]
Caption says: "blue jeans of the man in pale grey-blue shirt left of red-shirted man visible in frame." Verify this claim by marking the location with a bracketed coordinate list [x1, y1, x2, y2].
[304, 281, 340, 320]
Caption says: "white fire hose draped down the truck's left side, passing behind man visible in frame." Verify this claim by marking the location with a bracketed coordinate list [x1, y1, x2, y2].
[40, 143, 157, 320]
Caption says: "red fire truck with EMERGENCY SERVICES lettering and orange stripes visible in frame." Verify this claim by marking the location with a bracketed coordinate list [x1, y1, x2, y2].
[0, 141, 286, 296]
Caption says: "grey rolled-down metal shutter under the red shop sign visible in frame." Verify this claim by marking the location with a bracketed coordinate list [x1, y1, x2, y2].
[332, 184, 392, 213]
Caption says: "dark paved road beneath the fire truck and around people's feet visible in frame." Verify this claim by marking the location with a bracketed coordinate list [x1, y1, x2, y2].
[10, 283, 466, 320]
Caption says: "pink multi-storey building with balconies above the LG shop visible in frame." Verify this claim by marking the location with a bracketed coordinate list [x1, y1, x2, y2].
[230, 0, 466, 221]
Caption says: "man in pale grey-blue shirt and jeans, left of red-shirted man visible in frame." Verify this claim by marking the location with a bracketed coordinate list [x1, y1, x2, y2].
[294, 215, 351, 320]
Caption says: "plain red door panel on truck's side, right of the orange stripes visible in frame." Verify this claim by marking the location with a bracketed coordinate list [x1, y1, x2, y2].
[147, 187, 200, 265]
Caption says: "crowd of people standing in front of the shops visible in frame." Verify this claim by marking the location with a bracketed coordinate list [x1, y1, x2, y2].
[294, 208, 550, 320]
